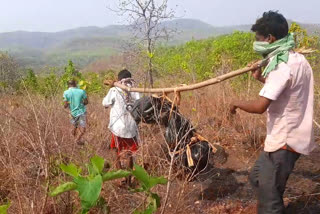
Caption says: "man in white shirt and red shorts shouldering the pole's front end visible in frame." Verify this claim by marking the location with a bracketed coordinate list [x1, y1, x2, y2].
[102, 69, 140, 185]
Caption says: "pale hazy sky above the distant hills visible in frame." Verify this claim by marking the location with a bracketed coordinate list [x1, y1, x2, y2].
[0, 0, 320, 32]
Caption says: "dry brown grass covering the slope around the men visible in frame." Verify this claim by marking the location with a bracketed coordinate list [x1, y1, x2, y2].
[0, 79, 318, 214]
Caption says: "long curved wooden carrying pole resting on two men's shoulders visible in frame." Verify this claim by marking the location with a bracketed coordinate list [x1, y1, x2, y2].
[104, 48, 315, 94]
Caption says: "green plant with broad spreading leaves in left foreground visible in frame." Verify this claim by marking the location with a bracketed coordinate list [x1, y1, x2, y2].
[50, 156, 131, 213]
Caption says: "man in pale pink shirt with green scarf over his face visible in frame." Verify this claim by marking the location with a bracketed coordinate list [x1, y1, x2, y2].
[230, 11, 316, 214]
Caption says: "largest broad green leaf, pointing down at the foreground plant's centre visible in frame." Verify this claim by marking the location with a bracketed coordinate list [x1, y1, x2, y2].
[74, 175, 102, 212]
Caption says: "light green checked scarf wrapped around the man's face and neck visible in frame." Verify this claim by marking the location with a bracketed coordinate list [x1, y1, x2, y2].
[253, 33, 296, 77]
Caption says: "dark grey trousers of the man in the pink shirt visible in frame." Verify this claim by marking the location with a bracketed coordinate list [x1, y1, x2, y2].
[249, 149, 300, 214]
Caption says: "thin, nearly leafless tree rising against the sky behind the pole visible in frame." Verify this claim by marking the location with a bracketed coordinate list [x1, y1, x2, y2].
[112, 0, 174, 87]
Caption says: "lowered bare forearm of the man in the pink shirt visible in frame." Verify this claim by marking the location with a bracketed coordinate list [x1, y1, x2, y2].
[230, 97, 272, 114]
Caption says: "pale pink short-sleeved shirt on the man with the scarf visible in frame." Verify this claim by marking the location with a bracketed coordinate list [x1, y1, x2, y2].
[259, 52, 316, 155]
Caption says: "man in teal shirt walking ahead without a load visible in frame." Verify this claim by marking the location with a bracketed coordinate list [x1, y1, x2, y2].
[63, 80, 88, 145]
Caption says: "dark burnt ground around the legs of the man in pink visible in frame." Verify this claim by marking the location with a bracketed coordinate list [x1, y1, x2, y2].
[170, 144, 320, 214]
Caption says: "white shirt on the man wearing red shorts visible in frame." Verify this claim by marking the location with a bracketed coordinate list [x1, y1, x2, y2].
[102, 87, 140, 138]
